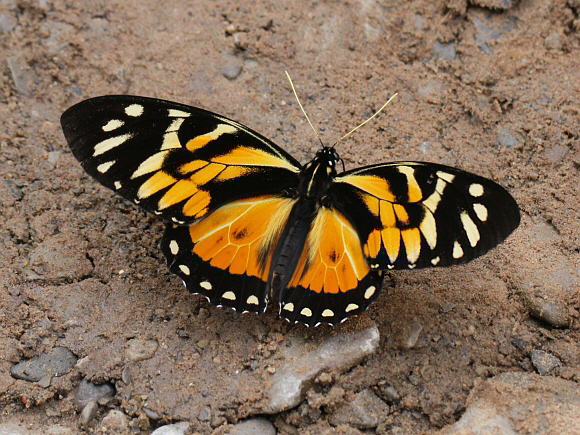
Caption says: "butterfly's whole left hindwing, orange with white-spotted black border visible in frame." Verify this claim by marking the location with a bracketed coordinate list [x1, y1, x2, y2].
[161, 196, 295, 313]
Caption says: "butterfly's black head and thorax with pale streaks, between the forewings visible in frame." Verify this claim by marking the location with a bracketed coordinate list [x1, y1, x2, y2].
[298, 147, 340, 200]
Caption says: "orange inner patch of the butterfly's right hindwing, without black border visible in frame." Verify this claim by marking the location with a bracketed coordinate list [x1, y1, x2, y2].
[288, 207, 370, 294]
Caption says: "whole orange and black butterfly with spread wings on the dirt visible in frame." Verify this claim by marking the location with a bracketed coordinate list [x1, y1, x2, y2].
[61, 96, 520, 326]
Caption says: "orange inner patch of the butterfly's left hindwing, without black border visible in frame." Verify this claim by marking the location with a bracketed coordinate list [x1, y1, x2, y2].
[189, 197, 296, 281]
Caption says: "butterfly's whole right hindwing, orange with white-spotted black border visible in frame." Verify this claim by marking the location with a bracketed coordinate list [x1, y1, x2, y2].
[279, 207, 383, 326]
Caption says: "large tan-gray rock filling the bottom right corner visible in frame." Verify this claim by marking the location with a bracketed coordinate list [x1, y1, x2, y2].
[437, 372, 580, 435]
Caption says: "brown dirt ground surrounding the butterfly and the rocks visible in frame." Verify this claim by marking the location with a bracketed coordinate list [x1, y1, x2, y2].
[0, 0, 580, 434]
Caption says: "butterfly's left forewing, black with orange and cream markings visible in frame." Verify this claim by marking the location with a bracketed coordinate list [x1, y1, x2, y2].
[61, 96, 300, 224]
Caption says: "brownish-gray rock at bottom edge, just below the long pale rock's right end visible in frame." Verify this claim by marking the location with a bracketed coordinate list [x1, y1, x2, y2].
[328, 388, 389, 429]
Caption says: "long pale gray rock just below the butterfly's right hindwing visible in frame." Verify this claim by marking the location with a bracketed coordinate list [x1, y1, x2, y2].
[263, 326, 379, 414]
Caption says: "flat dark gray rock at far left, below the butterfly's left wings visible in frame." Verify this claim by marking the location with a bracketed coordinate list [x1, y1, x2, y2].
[10, 347, 77, 382]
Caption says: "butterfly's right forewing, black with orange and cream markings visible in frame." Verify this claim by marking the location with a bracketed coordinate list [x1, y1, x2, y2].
[329, 162, 520, 269]
